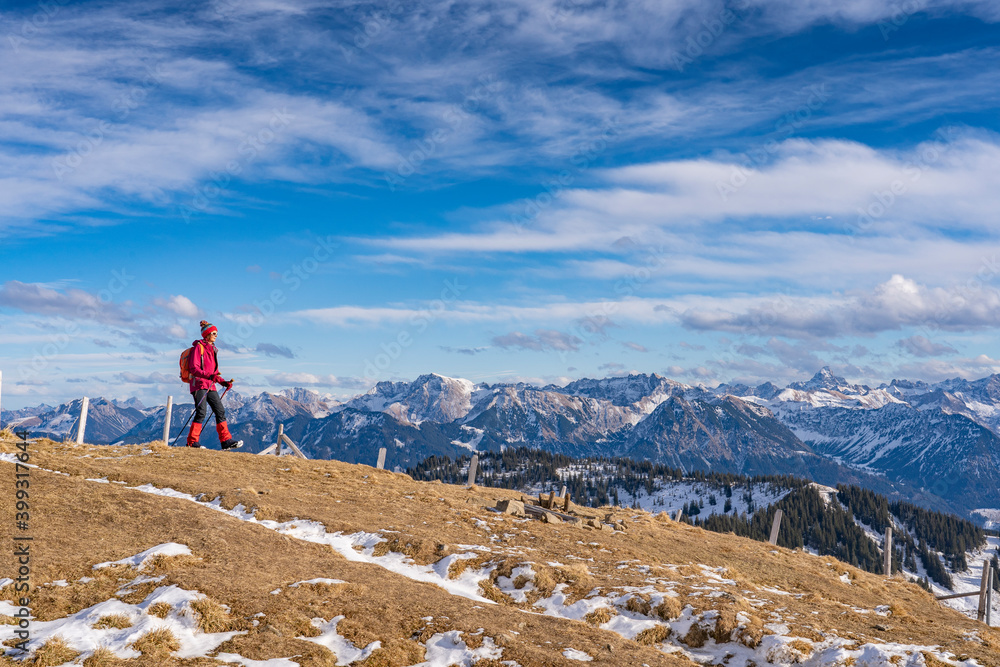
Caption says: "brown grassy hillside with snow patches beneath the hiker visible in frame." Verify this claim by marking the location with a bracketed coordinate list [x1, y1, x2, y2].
[0, 440, 1000, 667]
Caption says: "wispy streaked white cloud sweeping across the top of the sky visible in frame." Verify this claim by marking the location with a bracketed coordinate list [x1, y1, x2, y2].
[0, 0, 1000, 232]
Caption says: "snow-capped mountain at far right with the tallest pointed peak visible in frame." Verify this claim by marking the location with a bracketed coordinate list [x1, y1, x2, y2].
[716, 368, 1000, 509]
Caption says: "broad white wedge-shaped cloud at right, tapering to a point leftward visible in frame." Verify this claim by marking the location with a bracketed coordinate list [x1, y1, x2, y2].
[378, 134, 1000, 254]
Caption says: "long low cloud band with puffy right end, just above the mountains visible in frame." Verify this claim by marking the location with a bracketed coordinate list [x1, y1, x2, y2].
[289, 274, 1000, 349]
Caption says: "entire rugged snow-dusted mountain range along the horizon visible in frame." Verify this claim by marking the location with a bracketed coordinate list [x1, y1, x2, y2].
[7, 368, 1000, 515]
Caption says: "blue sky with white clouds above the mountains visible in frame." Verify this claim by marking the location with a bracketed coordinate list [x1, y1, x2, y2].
[0, 0, 1000, 408]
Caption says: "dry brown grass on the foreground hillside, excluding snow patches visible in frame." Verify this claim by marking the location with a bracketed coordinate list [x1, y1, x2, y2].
[7, 442, 1000, 667]
